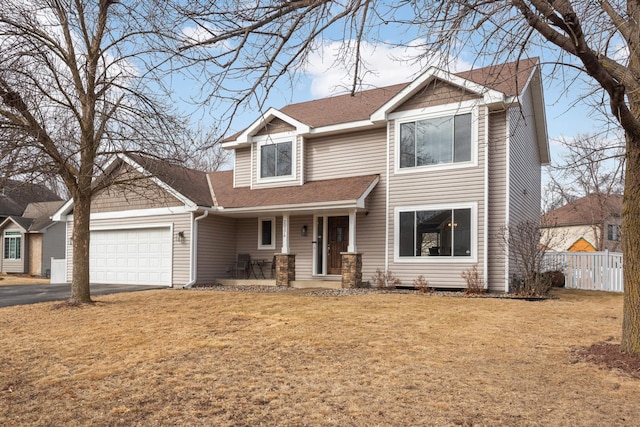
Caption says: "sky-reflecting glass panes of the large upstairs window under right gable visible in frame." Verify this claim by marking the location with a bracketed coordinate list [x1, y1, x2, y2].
[399, 113, 472, 168]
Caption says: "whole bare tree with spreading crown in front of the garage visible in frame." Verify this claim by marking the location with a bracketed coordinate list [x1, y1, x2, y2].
[0, 0, 200, 304]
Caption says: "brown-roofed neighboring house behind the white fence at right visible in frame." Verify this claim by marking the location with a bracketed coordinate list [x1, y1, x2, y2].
[542, 194, 622, 252]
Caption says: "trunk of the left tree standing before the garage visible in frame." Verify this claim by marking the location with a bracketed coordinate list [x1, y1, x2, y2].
[69, 194, 92, 304]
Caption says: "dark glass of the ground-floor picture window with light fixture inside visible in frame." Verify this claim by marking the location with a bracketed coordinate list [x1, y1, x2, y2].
[397, 208, 473, 259]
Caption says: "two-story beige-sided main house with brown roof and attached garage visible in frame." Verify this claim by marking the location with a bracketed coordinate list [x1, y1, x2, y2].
[55, 59, 549, 291]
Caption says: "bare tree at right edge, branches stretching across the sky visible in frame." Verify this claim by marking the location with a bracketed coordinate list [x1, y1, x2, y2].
[178, 0, 640, 353]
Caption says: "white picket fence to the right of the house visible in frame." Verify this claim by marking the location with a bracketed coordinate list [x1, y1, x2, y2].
[544, 251, 624, 292]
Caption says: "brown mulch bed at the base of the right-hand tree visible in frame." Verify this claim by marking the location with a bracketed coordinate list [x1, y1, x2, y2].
[572, 343, 640, 379]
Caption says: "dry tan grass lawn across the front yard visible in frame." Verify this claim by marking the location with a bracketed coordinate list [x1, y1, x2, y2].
[0, 290, 640, 426]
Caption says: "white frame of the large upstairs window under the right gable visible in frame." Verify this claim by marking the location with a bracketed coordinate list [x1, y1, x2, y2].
[389, 100, 479, 174]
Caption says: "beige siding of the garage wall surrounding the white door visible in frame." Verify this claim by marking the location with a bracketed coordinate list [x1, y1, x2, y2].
[67, 213, 191, 286]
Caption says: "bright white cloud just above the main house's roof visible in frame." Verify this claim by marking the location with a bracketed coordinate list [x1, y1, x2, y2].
[303, 40, 470, 97]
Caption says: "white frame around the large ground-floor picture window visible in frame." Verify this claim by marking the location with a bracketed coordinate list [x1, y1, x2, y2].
[393, 202, 478, 264]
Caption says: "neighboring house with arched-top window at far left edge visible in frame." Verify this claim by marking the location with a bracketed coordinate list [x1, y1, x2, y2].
[0, 200, 66, 276]
